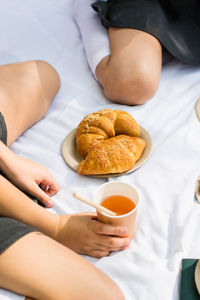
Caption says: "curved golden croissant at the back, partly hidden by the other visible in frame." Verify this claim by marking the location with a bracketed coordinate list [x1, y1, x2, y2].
[76, 109, 140, 158]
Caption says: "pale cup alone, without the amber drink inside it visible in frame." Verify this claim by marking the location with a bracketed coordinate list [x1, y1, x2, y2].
[94, 181, 139, 238]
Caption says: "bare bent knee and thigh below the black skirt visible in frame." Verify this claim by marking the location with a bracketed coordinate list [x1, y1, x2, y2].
[96, 28, 162, 105]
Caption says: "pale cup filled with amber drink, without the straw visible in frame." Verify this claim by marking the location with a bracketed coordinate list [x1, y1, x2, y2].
[94, 181, 139, 237]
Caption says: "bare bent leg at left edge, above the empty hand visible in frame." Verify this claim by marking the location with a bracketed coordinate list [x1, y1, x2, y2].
[0, 61, 60, 145]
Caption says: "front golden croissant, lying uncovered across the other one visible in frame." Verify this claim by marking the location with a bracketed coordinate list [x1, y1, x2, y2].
[78, 135, 146, 175]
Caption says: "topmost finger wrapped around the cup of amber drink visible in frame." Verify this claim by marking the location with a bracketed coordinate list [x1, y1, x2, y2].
[91, 221, 128, 237]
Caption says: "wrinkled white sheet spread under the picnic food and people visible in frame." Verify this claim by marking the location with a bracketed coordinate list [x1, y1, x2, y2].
[0, 0, 200, 300]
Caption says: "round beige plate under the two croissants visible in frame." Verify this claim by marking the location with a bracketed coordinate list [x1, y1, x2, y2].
[61, 127, 152, 178]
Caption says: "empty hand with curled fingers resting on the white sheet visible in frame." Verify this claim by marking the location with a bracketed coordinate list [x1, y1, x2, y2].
[1, 151, 59, 207]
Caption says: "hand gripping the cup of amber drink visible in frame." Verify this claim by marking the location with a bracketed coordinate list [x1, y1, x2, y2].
[54, 213, 131, 258]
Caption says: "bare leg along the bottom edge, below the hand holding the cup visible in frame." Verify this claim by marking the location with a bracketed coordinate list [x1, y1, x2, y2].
[0, 232, 124, 300]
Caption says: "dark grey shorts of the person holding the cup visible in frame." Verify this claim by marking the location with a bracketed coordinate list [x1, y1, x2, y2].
[0, 113, 38, 254]
